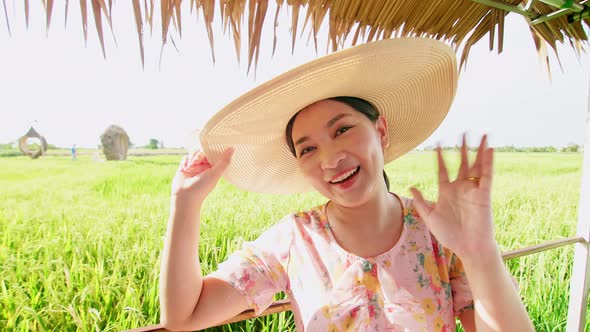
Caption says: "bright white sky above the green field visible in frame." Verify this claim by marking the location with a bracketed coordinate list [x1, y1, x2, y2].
[0, 1, 590, 147]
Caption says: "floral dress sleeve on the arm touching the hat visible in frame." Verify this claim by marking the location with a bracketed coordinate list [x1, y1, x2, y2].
[207, 215, 293, 315]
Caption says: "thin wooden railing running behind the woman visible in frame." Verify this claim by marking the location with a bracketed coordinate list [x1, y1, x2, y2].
[129, 236, 586, 332]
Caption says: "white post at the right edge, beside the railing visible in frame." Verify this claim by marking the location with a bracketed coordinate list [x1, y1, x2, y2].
[567, 74, 590, 332]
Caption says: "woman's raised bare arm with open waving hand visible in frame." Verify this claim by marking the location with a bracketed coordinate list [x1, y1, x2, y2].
[411, 136, 534, 332]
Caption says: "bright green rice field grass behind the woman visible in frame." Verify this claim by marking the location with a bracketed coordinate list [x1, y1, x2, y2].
[0, 153, 590, 331]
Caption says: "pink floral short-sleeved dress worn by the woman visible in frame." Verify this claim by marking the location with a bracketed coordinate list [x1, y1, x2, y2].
[209, 198, 473, 331]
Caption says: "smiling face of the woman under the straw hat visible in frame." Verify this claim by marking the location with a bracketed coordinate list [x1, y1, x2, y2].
[291, 100, 394, 207]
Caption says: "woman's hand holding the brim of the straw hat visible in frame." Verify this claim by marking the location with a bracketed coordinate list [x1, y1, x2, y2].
[172, 148, 234, 204]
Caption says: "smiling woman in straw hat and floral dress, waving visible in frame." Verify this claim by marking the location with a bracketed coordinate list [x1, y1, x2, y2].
[160, 38, 532, 331]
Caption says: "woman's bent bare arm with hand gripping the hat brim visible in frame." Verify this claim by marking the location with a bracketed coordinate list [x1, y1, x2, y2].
[160, 150, 248, 330]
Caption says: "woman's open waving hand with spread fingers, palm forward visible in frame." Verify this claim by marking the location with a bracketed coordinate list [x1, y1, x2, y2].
[410, 135, 497, 260]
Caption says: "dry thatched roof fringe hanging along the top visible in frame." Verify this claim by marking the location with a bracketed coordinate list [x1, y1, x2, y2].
[3, 0, 590, 68]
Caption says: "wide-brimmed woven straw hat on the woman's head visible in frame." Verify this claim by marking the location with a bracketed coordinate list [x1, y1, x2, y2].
[200, 38, 458, 194]
